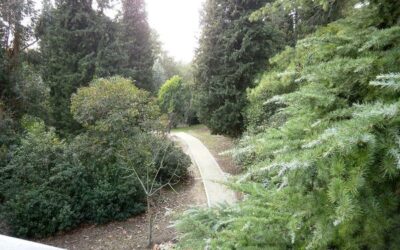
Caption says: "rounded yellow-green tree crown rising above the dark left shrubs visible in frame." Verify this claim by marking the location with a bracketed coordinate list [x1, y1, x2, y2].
[71, 77, 160, 132]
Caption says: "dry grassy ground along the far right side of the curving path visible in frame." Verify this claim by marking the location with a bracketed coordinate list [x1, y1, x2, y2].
[173, 125, 240, 175]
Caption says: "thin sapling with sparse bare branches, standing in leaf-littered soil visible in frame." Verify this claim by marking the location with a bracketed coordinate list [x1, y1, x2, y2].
[118, 135, 190, 246]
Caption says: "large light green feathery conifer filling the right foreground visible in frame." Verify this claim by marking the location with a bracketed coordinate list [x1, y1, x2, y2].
[177, 1, 400, 249]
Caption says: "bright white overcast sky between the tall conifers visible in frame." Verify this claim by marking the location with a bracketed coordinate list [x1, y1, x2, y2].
[146, 0, 204, 62]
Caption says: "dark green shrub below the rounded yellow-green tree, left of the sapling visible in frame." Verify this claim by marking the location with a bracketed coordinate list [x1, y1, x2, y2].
[68, 133, 144, 223]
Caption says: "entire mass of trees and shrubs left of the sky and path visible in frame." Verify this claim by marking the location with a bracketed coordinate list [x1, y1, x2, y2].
[0, 0, 189, 240]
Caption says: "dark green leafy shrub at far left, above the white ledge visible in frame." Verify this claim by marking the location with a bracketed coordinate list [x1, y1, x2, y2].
[0, 122, 78, 237]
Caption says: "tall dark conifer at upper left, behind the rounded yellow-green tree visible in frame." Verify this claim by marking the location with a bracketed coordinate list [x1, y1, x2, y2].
[38, 0, 101, 133]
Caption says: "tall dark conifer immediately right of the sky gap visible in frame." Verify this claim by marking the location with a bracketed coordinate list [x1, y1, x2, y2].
[195, 0, 281, 136]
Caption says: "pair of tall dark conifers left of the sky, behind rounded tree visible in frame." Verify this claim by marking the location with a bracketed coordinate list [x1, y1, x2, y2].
[36, 0, 154, 133]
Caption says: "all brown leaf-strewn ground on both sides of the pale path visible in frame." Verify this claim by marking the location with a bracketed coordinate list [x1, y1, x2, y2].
[0, 126, 231, 250]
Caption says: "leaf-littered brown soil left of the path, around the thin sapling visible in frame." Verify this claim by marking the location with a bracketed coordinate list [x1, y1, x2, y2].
[40, 140, 207, 250]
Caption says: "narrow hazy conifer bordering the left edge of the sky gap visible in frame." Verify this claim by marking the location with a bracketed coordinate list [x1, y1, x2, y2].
[118, 0, 154, 91]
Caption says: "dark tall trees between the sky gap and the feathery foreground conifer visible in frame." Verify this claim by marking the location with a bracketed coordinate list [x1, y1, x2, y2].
[194, 0, 352, 136]
